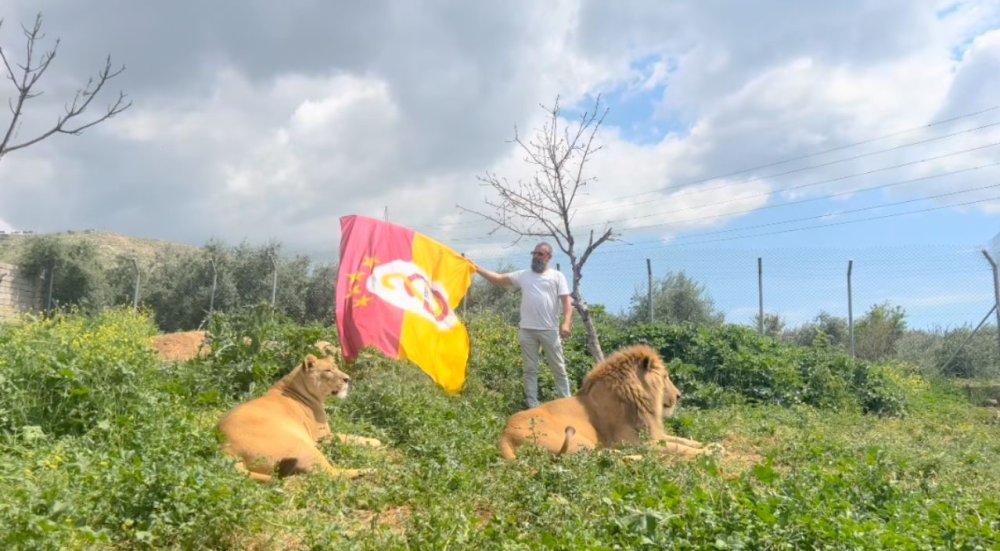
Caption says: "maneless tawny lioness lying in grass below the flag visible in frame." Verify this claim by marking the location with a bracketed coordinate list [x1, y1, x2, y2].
[219, 354, 382, 481]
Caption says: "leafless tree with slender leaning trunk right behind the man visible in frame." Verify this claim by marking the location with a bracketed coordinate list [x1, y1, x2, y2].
[459, 96, 616, 361]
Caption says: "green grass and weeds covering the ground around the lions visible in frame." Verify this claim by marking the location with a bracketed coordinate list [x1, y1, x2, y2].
[0, 313, 1000, 550]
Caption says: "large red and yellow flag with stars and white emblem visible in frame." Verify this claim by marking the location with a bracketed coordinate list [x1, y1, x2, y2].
[336, 216, 475, 393]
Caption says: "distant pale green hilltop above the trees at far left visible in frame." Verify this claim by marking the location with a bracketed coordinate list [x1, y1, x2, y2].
[0, 230, 198, 266]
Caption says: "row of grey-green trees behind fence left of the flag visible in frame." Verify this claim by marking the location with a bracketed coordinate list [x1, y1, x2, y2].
[0, 233, 336, 331]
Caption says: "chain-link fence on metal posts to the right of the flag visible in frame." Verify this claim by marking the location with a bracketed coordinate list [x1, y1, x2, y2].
[472, 243, 1000, 374]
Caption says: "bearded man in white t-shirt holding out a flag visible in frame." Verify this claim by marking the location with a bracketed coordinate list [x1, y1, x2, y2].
[476, 242, 573, 408]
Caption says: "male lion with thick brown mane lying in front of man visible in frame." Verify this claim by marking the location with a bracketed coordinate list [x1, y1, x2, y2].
[497, 345, 713, 460]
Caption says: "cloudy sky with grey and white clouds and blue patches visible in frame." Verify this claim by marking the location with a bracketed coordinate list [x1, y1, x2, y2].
[0, 0, 1000, 328]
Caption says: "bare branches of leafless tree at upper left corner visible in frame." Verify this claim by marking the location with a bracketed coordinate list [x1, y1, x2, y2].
[0, 14, 132, 160]
